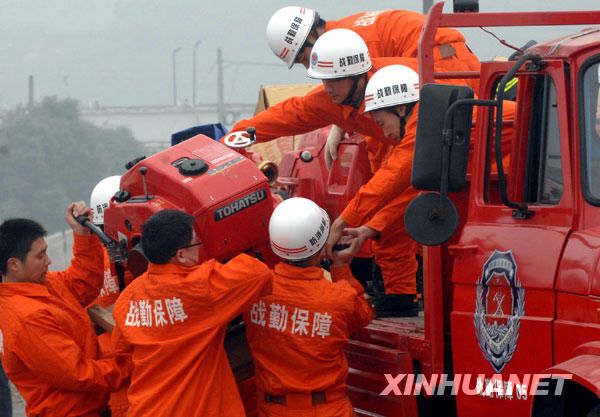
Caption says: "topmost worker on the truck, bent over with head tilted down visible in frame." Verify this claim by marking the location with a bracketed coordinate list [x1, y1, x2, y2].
[267, 6, 481, 166]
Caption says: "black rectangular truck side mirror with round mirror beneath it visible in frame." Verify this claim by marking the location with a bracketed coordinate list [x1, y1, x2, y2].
[404, 84, 475, 246]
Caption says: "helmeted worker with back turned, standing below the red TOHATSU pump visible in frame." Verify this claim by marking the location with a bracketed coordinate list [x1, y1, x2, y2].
[244, 198, 373, 417]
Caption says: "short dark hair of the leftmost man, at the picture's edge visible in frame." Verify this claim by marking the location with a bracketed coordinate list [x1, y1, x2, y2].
[0, 219, 46, 275]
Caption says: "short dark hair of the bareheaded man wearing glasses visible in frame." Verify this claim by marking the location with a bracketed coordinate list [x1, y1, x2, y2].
[142, 210, 194, 264]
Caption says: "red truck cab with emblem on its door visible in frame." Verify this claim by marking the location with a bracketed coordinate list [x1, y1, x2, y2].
[407, 3, 600, 417]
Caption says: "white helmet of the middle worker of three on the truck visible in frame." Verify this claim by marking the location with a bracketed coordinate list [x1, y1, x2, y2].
[307, 29, 372, 80]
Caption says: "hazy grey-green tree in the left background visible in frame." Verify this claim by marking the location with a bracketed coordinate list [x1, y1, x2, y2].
[0, 97, 144, 233]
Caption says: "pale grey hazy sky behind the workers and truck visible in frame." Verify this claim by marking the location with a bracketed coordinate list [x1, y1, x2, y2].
[0, 0, 600, 108]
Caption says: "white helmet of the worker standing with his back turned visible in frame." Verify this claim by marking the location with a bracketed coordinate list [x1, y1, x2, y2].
[269, 197, 329, 261]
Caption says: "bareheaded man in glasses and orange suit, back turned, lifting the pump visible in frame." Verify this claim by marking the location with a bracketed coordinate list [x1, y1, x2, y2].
[113, 210, 272, 417]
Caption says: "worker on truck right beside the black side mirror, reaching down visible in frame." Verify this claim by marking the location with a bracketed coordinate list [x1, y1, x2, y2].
[326, 65, 419, 317]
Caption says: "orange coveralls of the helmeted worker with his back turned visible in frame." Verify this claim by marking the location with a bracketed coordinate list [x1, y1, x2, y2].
[244, 263, 373, 417]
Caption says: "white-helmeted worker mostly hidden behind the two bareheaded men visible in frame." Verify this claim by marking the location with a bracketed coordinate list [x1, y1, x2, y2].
[90, 175, 133, 417]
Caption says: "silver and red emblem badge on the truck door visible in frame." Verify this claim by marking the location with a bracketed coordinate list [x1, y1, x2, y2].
[474, 250, 525, 373]
